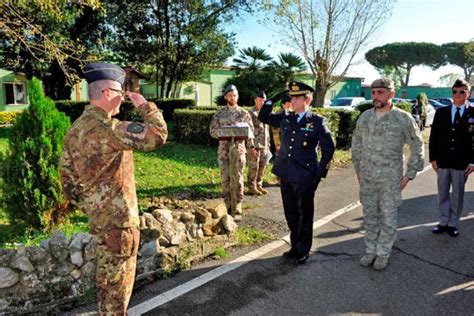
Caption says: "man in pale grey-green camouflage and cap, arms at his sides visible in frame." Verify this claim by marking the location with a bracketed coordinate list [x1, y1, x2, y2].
[352, 79, 424, 270]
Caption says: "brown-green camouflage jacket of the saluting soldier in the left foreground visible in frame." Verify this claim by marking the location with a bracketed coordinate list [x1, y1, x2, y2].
[61, 102, 168, 232]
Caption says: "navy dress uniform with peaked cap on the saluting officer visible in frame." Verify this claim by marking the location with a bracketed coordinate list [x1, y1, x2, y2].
[258, 82, 334, 263]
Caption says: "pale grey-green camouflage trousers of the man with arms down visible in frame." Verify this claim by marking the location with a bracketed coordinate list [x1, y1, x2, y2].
[359, 179, 402, 258]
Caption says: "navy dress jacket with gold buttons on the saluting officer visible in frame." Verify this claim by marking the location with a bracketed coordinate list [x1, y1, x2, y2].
[258, 102, 334, 184]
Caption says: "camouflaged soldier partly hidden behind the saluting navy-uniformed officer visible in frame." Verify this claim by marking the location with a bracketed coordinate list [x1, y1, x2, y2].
[247, 92, 270, 195]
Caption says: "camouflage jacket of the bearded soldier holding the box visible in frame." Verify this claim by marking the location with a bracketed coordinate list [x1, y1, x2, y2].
[209, 105, 254, 154]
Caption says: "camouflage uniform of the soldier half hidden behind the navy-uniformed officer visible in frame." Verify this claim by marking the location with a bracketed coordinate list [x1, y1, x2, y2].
[247, 107, 270, 189]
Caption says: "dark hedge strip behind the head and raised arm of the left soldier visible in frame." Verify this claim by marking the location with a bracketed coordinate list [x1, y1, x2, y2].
[56, 99, 196, 122]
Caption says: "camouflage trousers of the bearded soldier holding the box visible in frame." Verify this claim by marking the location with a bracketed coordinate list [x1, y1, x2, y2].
[217, 142, 246, 205]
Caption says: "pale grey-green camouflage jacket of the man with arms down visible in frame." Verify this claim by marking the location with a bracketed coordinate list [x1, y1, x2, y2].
[352, 106, 424, 181]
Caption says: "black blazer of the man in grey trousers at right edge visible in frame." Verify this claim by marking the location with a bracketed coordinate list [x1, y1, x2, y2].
[430, 105, 474, 170]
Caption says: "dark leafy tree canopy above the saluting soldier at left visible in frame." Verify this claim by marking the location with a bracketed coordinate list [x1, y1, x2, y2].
[110, 0, 250, 98]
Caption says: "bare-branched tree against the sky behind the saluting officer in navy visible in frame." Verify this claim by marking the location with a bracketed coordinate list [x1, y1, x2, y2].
[263, 0, 393, 106]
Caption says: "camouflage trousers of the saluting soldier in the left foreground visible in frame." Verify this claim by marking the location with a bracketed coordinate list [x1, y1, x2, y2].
[95, 227, 140, 315]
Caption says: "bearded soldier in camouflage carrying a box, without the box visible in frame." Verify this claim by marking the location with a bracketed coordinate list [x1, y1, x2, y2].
[209, 85, 256, 216]
